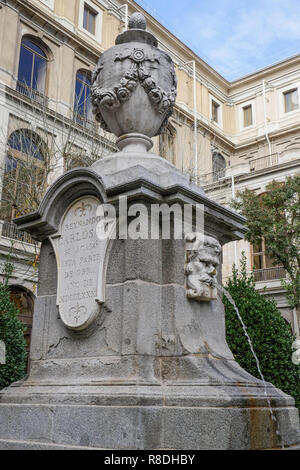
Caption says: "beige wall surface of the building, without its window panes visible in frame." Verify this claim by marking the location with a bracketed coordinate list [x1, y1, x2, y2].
[0, 0, 300, 332]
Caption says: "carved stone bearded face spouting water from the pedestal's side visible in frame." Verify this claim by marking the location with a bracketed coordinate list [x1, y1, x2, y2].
[185, 235, 221, 301]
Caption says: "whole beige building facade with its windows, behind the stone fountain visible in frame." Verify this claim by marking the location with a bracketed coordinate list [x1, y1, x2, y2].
[0, 0, 300, 346]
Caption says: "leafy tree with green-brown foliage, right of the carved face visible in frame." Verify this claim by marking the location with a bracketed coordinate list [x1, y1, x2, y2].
[233, 175, 300, 320]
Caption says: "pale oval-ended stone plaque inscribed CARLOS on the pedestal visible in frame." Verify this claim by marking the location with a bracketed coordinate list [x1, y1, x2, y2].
[51, 196, 113, 330]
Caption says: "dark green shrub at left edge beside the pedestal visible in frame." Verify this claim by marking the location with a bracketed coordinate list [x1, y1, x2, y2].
[0, 267, 27, 390]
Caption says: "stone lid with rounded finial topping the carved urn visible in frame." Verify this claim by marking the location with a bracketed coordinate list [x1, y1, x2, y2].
[116, 12, 158, 47]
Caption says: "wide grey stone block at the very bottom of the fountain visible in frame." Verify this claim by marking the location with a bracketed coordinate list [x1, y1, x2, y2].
[0, 387, 300, 450]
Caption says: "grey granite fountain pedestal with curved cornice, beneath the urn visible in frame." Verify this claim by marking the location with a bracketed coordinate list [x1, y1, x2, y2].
[0, 153, 299, 449]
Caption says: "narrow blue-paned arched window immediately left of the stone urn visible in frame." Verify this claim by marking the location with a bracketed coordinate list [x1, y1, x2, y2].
[74, 70, 92, 123]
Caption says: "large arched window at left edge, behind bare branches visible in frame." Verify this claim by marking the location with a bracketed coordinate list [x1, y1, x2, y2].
[1, 129, 47, 222]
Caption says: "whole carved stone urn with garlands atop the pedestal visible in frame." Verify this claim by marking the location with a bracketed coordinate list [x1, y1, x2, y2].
[92, 13, 177, 151]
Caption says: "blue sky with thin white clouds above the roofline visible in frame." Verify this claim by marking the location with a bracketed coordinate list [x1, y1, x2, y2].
[137, 0, 300, 81]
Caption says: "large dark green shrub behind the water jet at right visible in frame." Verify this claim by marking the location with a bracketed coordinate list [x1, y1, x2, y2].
[223, 255, 300, 409]
